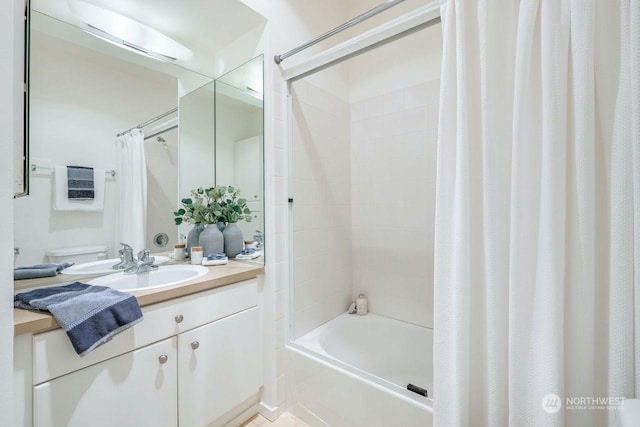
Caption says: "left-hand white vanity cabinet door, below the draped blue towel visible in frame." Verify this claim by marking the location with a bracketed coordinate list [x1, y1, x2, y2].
[34, 337, 178, 427]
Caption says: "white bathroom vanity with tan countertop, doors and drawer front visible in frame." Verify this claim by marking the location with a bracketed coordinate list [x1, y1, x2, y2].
[14, 261, 264, 427]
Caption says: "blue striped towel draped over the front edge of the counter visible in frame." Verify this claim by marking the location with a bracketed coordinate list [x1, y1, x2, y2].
[13, 282, 142, 356]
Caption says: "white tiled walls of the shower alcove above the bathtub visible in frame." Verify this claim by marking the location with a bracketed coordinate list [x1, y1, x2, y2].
[292, 80, 439, 338]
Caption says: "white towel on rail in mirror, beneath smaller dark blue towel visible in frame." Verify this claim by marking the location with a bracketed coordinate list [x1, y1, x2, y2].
[53, 166, 106, 212]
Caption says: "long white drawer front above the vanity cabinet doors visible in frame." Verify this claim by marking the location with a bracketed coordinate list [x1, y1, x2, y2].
[33, 279, 258, 385]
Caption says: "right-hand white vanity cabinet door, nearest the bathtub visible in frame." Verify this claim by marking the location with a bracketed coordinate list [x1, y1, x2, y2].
[178, 307, 261, 427]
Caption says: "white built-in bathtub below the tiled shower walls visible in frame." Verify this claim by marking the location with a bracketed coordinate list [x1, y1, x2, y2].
[287, 313, 433, 427]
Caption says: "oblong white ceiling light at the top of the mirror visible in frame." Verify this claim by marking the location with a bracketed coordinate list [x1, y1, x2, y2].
[69, 0, 193, 61]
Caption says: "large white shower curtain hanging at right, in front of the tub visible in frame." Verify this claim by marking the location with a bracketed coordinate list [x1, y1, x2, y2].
[434, 0, 640, 427]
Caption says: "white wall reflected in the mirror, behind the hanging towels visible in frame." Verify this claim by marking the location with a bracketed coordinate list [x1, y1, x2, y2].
[14, 32, 177, 265]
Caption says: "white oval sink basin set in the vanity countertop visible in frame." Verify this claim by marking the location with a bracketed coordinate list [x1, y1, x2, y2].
[88, 265, 209, 292]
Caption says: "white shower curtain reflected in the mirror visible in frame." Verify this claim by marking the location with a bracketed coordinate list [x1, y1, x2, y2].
[115, 129, 147, 251]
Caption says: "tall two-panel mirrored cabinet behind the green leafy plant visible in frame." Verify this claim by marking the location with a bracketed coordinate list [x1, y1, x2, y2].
[180, 55, 264, 262]
